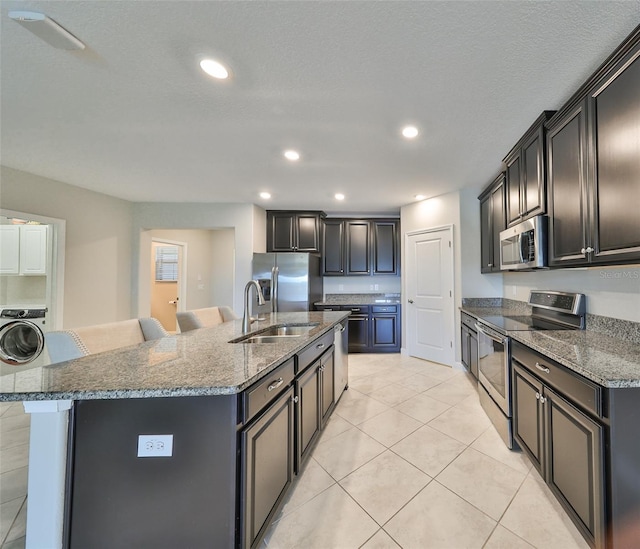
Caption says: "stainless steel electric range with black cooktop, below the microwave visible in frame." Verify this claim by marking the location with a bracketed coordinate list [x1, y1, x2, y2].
[476, 290, 586, 448]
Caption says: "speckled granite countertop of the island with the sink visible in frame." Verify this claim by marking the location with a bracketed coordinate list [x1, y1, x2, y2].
[0, 312, 348, 401]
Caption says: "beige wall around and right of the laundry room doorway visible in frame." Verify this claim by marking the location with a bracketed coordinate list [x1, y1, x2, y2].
[0, 166, 132, 328]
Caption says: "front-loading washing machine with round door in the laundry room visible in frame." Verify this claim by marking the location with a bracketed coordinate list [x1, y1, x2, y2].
[0, 307, 47, 366]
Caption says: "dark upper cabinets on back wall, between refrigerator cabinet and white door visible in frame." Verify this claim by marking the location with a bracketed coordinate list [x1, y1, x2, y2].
[322, 219, 400, 276]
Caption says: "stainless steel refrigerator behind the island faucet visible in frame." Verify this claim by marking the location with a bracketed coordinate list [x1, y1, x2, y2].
[252, 252, 322, 315]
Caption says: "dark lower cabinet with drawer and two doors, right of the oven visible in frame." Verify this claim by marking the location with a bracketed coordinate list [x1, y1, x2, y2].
[512, 345, 606, 547]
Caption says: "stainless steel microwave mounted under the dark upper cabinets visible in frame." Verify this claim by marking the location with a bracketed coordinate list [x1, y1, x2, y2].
[500, 215, 548, 271]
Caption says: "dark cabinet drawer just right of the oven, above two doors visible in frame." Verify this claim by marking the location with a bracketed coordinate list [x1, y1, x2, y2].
[511, 341, 603, 418]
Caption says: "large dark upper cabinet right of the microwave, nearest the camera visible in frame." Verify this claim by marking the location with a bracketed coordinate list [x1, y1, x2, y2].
[547, 27, 640, 266]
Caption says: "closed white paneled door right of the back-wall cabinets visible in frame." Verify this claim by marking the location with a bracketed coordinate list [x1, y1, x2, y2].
[405, 227, 455, 366]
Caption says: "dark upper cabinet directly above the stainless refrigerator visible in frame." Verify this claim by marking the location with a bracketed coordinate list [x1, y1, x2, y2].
[267, 210, 324, 253]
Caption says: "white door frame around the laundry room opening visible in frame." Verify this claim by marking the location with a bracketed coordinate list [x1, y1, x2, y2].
[0, 208, 67, 331]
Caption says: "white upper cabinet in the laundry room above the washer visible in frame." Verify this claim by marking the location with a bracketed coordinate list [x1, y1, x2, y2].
[0, 225, 48, 275]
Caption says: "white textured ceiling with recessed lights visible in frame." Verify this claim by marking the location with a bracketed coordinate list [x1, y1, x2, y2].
[0, 0, 640, 213]
